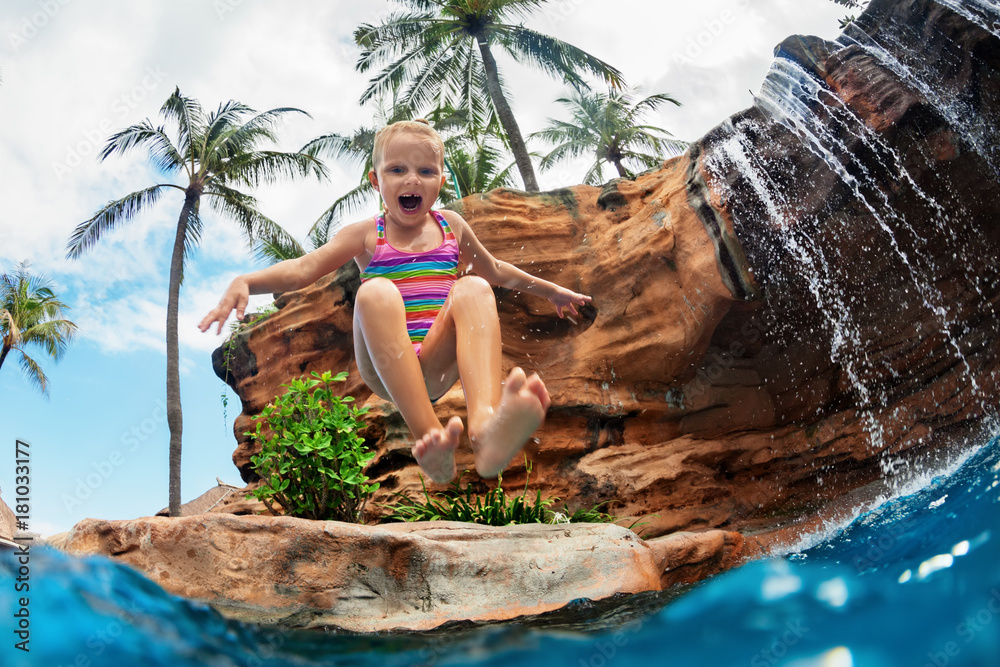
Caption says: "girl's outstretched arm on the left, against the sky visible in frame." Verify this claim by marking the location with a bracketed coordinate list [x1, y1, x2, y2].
[198, 220, 371, 335]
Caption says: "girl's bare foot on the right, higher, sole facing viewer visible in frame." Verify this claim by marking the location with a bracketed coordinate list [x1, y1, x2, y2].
[469, 368, 549, 478]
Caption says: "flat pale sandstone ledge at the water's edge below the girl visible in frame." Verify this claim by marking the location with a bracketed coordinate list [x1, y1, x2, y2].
[66, 514, 666, 632]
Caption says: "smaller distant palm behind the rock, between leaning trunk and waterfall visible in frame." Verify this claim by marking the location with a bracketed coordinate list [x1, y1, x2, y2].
[531, 90, 687, 185]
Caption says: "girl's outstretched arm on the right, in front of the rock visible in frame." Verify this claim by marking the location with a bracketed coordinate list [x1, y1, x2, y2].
[442, 211, 591, 317]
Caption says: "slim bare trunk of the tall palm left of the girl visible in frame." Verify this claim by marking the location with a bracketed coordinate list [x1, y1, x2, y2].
[167, 189, 193, 516]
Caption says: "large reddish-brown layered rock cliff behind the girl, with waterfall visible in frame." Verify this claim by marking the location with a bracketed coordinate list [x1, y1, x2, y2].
[214, 0, 1000, 548]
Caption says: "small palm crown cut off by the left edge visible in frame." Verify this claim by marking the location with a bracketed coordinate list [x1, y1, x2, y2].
[0, 261, 76, 396]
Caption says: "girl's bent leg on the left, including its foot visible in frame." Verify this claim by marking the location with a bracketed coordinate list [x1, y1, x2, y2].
[354, 278, 462, 482]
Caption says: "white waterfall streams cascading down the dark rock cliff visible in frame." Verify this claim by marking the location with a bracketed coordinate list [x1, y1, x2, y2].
[703, 0, 1000, 475]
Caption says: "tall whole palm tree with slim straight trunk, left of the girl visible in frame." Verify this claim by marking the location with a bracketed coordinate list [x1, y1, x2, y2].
[66, 89, 326, 516]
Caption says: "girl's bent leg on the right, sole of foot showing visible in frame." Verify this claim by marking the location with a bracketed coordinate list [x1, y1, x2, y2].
[418, 276, 549, 477]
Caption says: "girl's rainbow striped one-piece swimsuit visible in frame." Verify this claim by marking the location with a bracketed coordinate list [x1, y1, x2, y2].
[361, 211, 458, 356]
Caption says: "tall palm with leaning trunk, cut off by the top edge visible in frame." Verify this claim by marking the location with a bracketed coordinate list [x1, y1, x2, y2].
[354, 0, 624, 192]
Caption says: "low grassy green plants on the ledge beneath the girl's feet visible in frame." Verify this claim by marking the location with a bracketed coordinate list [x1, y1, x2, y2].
[386, 464, 615, 526]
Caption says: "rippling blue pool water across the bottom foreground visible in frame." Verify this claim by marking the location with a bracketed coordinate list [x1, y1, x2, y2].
[0, 430, 1000, 667]
